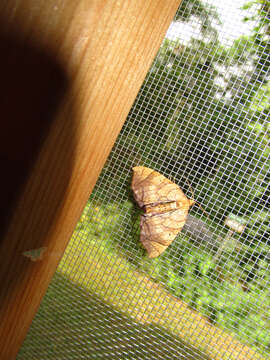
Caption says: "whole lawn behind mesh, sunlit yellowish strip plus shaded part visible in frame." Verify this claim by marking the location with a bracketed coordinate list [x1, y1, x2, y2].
[17, 198, 263, 360]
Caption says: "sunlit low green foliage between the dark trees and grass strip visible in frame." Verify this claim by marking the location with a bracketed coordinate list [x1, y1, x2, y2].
[75, 200, 270, 358]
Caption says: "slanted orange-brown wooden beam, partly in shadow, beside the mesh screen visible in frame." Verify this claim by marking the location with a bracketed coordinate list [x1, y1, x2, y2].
[0, 0, 180, 360]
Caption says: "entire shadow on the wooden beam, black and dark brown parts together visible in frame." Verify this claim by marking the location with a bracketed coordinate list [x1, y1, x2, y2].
[0, 19, 76, 316]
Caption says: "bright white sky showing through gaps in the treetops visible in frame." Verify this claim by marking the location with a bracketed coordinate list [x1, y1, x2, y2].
[166, 0, 254, 46]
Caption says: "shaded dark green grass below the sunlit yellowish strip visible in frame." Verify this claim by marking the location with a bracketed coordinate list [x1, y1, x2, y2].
[17, 273, 210, 360]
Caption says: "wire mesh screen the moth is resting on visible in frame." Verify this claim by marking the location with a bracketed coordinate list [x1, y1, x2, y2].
[18, 0, 270, 359]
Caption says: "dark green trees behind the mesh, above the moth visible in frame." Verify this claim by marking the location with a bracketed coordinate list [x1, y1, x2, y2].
[105, 0, 270, 242]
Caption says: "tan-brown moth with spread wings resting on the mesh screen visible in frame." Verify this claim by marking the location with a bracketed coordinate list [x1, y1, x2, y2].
[131, 166, 195, 258]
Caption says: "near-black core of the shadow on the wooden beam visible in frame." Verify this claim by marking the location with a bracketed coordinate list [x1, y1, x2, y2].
[0, 27, 72, 235]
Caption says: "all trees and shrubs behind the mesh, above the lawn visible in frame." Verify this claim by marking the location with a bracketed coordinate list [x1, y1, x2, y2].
[84, 0, 270, 351]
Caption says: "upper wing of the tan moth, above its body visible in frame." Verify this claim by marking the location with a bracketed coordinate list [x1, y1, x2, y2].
[131, 166, 188, 207]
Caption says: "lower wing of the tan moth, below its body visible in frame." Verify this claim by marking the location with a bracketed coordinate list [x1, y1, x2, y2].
[140, 208, 188, 258]
